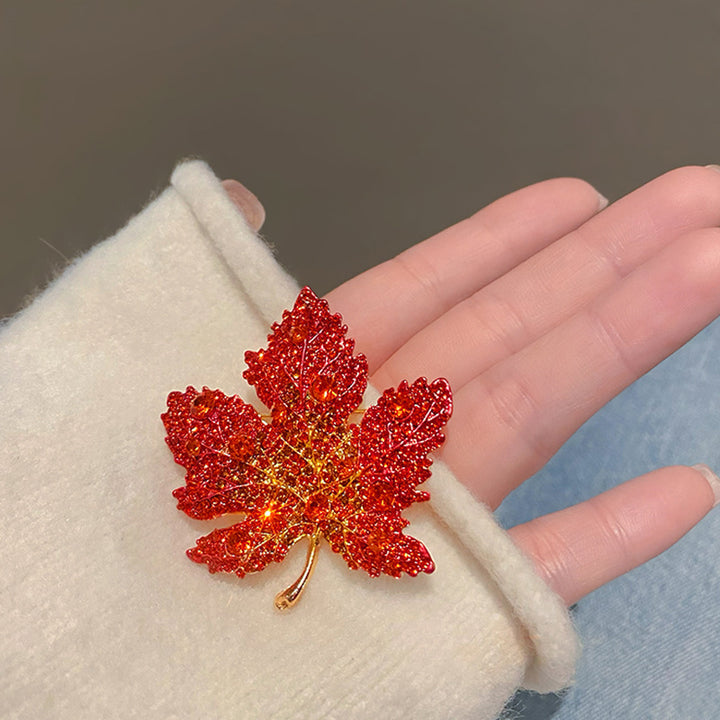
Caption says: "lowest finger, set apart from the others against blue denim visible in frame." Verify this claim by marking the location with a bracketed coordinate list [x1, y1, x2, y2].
[509, 466, 720, 605]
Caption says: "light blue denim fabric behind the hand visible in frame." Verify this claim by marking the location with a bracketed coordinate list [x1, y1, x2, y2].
[498, 321, 720, 720]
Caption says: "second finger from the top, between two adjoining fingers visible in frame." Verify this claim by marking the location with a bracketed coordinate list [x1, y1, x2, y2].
[373, 168, 720, 390]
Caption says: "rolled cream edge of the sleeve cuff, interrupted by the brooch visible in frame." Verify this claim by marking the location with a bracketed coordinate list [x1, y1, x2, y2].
[171, 161, 578, 692]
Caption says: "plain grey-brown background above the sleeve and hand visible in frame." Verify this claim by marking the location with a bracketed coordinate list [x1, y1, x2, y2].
[5, 0, 720, 316]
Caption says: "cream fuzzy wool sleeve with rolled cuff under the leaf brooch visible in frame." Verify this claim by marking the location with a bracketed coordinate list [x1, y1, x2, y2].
[0, 161, 577, 720]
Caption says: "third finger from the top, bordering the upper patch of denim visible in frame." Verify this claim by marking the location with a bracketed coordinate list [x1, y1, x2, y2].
[443, 228, 720, 506]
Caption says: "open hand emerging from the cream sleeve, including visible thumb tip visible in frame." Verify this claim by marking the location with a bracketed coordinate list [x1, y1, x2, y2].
[223, 167, 720, 604]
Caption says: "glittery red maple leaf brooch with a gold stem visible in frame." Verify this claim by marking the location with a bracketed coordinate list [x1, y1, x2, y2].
[162, 287, 452, 610]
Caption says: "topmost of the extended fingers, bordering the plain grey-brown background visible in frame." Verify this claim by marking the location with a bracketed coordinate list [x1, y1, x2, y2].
[327, 178, 607, 372]
